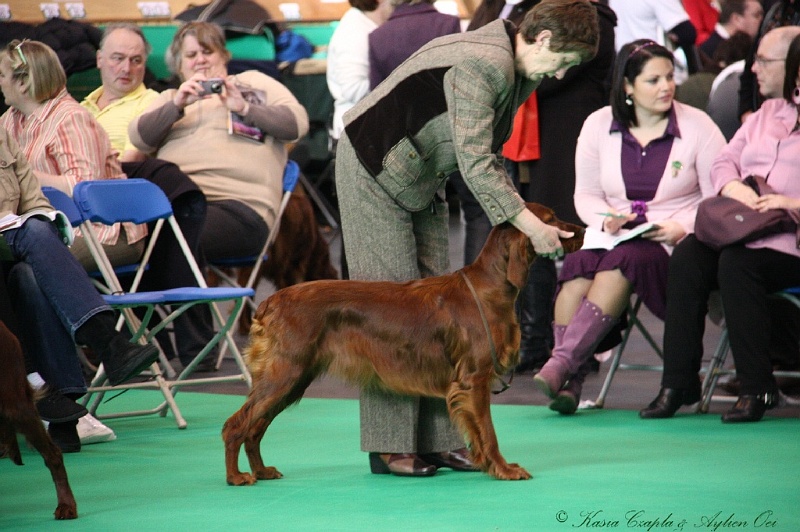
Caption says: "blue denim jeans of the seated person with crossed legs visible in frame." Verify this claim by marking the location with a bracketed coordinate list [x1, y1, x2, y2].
[3, 218, 111, 392]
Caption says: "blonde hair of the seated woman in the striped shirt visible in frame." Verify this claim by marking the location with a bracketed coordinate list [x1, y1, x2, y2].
[0, 40, 67, 103]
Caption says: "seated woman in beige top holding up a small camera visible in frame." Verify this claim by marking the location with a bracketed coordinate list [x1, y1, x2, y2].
[128, 22, 308, 261]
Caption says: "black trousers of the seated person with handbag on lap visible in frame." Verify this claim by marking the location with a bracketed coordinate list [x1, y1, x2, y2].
[662, 235, 800, 395]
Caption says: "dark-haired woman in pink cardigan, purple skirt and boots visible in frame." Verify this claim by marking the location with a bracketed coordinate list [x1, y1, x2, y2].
[534, 40, 725, 414]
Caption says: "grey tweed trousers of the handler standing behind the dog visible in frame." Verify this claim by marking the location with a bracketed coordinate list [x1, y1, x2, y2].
[336, 134, 464, 453]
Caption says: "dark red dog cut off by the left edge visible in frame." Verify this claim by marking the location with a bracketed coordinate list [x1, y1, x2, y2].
[0, 321, 78, 519]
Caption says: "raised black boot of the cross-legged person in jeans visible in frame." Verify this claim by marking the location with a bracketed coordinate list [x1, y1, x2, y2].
[75, 312, 158, 386]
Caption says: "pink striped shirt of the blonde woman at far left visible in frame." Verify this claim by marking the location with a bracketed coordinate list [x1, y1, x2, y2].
[0, 89, 147, 245]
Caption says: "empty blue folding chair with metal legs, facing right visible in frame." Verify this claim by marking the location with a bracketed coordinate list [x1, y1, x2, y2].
[74, 179, 253, 428]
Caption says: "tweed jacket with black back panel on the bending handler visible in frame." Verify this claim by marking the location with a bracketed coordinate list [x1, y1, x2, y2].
[344, 20, 536, 225]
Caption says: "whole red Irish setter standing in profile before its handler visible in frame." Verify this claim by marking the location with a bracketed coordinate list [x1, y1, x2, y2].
[222, 203, 583, 486]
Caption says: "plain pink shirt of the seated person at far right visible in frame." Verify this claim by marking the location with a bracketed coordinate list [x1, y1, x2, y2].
[711, 98, 800, 257]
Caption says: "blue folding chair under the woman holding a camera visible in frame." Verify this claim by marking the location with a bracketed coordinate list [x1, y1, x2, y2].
[208, 159, 300, 320]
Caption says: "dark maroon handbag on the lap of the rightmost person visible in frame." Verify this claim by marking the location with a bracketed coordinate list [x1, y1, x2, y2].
[694, 176, 800, 250]
